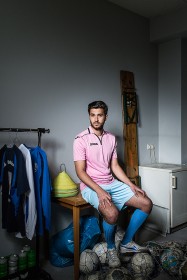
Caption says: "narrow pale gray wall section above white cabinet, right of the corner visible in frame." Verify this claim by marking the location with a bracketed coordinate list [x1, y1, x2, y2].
[158, 39, 182, 164]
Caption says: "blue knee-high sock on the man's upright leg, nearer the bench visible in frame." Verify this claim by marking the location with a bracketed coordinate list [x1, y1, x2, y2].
[103, 220, 117, 249]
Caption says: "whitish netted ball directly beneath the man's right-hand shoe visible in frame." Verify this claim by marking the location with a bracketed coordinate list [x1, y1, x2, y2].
[131, 253, 155, 278]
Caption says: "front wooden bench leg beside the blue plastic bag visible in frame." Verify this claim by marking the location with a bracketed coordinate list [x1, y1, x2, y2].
[73, 206, 80, 280]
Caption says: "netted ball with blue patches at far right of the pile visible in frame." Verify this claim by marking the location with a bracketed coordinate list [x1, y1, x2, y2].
[160, 247, 184, 275]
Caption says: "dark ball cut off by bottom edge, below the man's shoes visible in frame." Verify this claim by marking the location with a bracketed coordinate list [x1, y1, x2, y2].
[105, 266, 132, 280]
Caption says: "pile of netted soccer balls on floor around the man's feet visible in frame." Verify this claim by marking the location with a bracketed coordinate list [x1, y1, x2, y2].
[80, 229, 187, 280]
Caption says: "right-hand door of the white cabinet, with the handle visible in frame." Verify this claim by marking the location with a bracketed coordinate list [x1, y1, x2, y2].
[171, 171, 187, 228]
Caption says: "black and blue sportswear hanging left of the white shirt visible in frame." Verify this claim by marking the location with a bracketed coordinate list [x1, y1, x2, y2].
[0, 145, 30, 236]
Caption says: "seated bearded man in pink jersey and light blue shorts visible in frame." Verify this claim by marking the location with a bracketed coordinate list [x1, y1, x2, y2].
[73, 101, 152, 267]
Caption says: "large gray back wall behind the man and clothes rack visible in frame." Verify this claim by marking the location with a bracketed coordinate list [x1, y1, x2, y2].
[0, 0, 158, 258]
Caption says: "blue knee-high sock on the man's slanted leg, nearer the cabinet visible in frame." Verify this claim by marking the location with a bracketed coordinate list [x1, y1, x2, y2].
[121, 209, 148, 245]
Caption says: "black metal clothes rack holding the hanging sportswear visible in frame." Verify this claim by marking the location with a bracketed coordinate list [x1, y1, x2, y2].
[0, 128, 52, 280]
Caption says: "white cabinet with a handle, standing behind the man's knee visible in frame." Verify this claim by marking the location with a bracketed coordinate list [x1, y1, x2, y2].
[139, 163, 187, 234]
